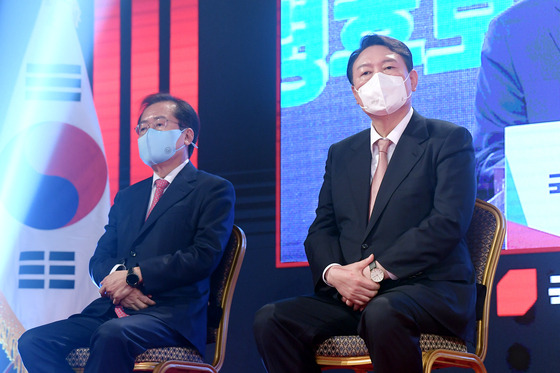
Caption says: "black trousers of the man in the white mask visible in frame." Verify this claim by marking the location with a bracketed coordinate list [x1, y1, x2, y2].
[253, 291, 449, 373]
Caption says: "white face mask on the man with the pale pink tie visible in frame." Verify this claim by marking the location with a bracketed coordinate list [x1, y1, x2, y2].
[356, 73, 412, 115]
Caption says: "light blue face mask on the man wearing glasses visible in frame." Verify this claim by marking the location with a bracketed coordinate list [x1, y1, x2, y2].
[138, 128, 185, 167]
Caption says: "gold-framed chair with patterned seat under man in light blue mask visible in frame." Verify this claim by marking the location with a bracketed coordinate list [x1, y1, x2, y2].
[66, 225, 247, 373]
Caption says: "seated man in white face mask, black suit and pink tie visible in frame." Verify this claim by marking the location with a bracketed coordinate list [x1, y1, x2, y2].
[254, 35, 476, 373]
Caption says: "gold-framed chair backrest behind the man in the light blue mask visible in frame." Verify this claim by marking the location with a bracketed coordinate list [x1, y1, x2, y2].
[207, 225, 247, 371]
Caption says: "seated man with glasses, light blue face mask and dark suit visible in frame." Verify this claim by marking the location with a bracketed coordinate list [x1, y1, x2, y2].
[18, 93, 235, 373]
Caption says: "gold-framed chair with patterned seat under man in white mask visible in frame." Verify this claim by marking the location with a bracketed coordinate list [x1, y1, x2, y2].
[315, 199, 506, 373]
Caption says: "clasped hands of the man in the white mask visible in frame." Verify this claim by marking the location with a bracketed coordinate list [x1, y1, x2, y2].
[325, 255, 380, 311]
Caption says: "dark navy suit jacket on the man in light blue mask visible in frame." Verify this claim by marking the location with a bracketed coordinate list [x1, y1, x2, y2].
[83, 162, 235, 353]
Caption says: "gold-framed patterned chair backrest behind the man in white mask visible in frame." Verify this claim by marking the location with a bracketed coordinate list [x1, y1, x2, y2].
[466, 199, 506, 360]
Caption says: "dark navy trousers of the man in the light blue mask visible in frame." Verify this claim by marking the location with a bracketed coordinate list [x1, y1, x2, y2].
[18, 309, 188, 373]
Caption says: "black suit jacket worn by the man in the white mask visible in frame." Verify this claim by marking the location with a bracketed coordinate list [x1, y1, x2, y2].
[305, 112, 476, 341]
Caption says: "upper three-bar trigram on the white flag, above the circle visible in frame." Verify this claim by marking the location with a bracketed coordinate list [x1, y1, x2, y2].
[25, 63, 82, 101]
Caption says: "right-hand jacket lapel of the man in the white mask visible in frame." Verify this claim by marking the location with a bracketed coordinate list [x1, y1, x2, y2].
[364, 111, 428, 238]
